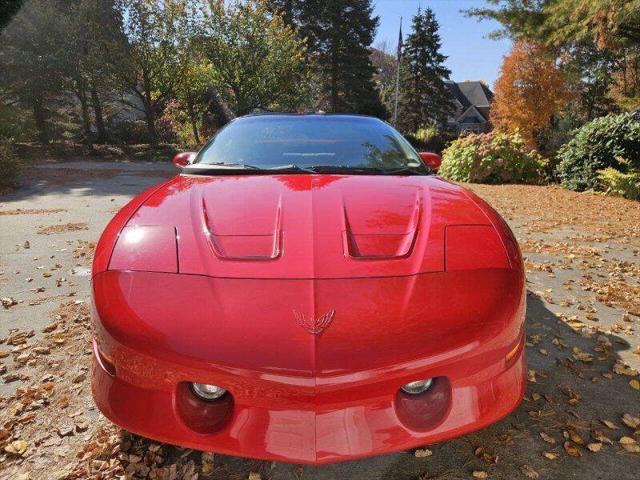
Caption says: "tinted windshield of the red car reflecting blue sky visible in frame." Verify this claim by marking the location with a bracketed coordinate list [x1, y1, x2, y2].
[194, 115, 428, 173]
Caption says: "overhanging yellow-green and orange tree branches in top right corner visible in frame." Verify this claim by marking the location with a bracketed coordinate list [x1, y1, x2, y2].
[466, 0, 640, 109]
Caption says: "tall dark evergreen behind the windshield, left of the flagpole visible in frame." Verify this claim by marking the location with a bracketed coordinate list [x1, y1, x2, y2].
[267, 0, 387, 117]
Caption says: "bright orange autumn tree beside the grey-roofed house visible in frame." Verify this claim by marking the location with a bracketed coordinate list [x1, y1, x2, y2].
[491, 41, 571, 148]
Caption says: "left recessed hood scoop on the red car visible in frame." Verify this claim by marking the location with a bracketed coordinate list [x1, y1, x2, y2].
[202, 198, 282, 261]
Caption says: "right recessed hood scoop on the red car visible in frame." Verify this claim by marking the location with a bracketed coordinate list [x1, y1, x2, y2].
[343, 188, 422, 260]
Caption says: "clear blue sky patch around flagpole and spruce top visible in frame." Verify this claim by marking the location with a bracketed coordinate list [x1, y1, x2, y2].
[373, 0, 511, 85]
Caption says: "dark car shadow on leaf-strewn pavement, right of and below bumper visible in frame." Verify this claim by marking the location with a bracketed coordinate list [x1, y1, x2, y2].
[114, 292, 639, 480]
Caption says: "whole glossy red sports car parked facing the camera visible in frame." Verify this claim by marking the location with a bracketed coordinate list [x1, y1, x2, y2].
[93, 114, 526, 464]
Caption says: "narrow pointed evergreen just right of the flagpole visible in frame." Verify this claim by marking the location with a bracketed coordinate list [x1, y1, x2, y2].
[398, 8, 452, 133]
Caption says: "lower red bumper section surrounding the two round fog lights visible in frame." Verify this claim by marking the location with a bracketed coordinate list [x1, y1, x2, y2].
[93, 338, 526, 464]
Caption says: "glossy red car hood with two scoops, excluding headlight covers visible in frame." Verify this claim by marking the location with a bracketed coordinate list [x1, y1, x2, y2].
[122, 174, 490, 278]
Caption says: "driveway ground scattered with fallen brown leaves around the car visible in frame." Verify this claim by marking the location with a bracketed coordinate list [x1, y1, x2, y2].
[0, 166, 640, 480]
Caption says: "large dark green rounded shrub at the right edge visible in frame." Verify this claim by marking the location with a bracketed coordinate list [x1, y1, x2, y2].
[557, 113, 640, 191]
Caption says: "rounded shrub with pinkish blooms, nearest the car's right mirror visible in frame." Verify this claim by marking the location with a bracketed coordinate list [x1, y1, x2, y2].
[439, 132, 544, 183]
